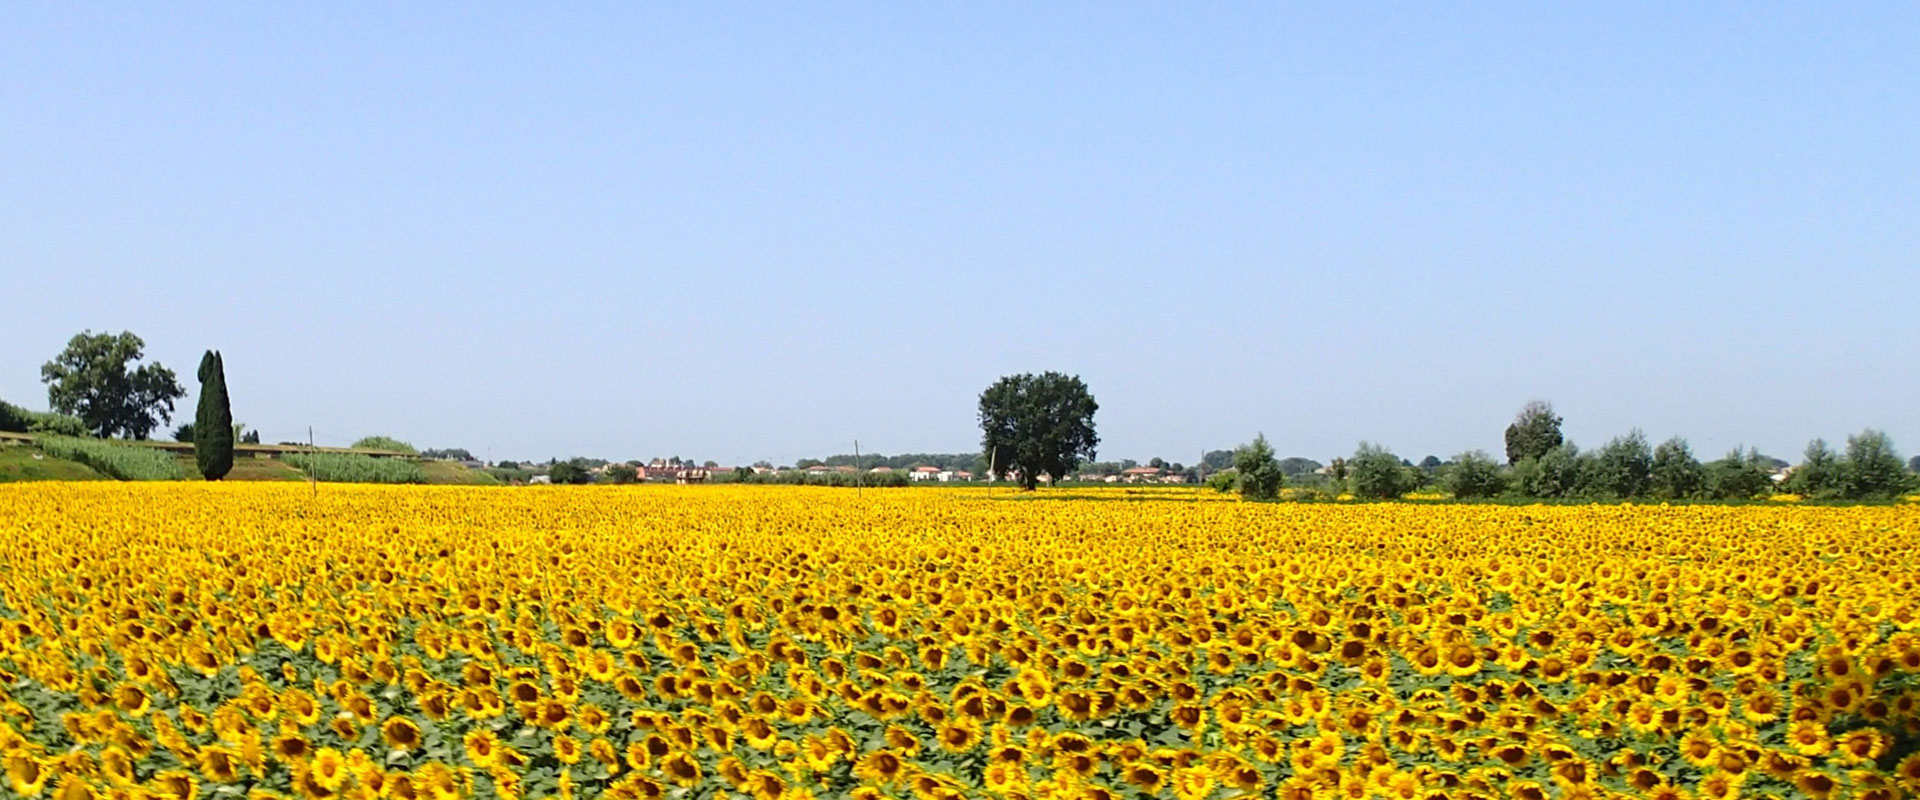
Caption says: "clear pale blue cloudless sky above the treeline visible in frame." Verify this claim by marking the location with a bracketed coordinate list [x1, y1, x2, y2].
[0, 2, 1920, 464]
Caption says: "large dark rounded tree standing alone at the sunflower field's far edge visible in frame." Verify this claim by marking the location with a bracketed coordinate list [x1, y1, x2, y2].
[979, 372, 1100, 491]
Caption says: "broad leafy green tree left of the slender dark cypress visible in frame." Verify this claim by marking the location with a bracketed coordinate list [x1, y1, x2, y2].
[40, 330, 186, 439]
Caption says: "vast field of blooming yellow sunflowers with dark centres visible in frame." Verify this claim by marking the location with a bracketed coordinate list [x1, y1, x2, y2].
[0, 483, 1920, 800]
